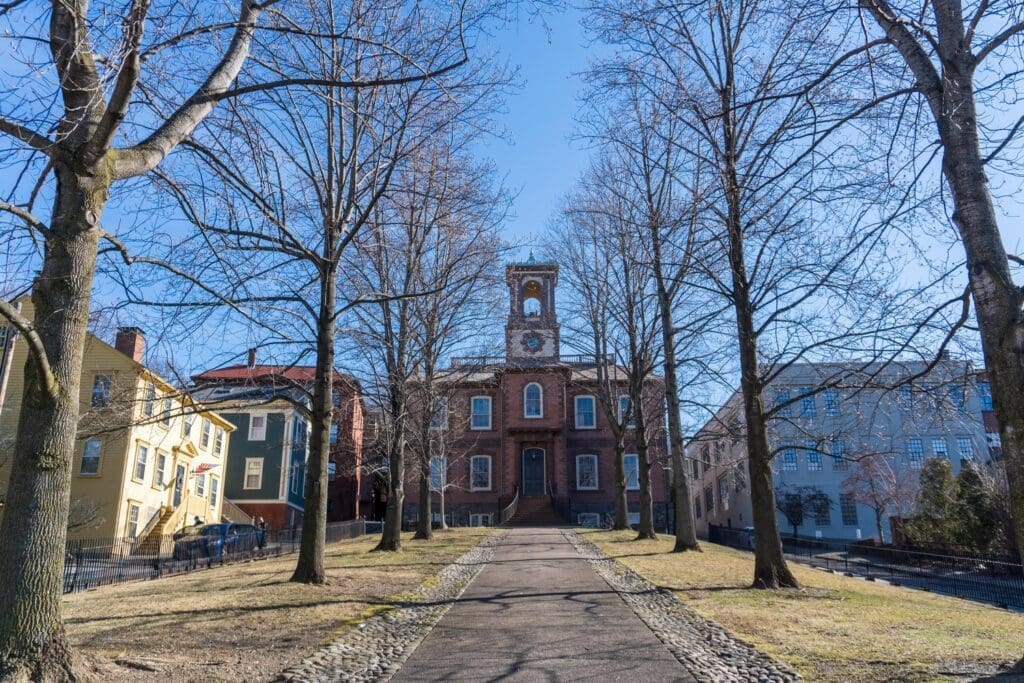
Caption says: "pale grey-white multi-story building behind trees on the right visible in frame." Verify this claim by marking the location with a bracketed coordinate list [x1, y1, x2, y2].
[687, 359, 987, 541]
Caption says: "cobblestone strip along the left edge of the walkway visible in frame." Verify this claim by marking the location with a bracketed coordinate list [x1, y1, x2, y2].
[274, 533, 504, 682]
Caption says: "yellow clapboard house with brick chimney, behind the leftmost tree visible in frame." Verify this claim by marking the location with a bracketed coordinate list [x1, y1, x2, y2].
[0, 297, 234, 546]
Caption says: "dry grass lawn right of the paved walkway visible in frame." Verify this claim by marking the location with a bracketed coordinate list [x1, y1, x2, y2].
[580, 529, 1024, 682]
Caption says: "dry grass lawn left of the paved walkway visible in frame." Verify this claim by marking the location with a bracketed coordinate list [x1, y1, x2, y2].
[63, 528, 494, 681]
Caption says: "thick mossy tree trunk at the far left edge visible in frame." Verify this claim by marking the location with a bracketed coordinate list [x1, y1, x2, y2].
[0, 163, 109, 680]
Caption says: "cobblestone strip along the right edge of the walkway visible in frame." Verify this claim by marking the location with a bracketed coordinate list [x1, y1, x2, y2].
[563, 529, 800, 683]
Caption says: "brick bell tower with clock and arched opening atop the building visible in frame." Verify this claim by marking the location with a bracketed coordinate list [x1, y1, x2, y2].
[505, 252, 558, 362]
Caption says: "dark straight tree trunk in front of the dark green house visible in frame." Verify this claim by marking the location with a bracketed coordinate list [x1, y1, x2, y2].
[292, 264, 338, 584]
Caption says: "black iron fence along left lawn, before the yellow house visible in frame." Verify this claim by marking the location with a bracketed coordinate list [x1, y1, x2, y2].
[63, 519, 372, 593]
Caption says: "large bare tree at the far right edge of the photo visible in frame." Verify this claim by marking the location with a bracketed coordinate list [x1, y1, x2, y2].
[851, 0, 1024, 565]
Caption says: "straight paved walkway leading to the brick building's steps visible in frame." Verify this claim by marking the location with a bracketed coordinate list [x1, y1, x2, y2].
[393, 528, 693, 683]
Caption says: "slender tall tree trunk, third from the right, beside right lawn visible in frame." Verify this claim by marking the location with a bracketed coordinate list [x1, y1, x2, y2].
[650, 221, 700, 553]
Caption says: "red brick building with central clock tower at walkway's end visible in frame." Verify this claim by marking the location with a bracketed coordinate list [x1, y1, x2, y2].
[404, 259, 670, 526]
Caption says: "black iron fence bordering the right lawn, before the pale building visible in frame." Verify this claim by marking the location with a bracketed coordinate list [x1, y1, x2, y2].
[708, 525, 1024, 609]
